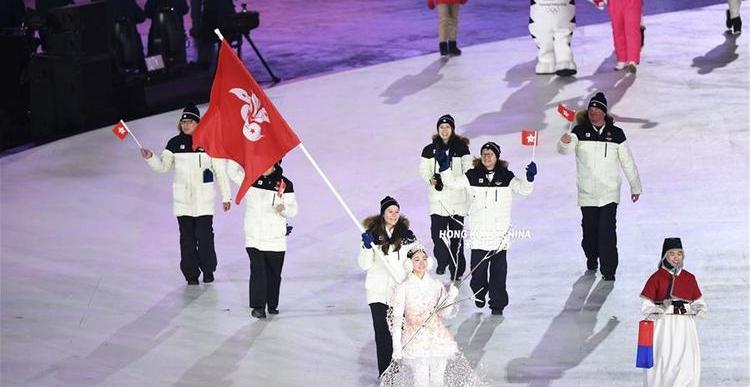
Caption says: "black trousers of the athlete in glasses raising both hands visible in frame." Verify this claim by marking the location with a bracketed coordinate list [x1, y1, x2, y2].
[469, 249, 508, 309]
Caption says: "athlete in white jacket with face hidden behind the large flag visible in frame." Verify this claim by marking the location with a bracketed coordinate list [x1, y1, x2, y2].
[227, 161, 297, 318]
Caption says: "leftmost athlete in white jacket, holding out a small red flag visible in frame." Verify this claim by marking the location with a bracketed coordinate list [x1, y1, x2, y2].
[141, 104, 231, 285]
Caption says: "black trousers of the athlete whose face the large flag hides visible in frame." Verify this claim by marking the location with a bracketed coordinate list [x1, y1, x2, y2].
[245, 247, 286, 309]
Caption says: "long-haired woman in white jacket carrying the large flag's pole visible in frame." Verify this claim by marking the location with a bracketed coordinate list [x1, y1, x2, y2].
[358, 196, 417, 375]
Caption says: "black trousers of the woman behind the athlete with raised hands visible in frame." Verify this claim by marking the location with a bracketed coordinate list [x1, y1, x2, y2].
[430, 214, 466, 280]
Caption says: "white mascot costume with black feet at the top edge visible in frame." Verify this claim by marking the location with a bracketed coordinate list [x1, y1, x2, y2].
[529, 0, 577, 76]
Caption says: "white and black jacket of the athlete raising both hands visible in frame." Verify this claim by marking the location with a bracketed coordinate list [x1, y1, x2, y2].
[441, 164, 534, 251]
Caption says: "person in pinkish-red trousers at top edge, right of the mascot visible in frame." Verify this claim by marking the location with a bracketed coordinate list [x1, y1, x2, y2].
[607, 0, 643, 73]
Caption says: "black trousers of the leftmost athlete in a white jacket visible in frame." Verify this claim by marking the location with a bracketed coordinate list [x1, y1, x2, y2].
[177, 215, 216, 281]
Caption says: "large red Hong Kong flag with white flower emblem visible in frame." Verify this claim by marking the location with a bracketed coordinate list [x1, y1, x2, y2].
[193, 40, 300, 204]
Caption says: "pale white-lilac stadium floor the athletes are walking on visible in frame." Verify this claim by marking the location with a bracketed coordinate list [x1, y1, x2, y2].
[0, 4, 750, 386]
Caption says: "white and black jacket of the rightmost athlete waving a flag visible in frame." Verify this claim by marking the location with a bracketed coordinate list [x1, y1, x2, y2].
[557, 120, 641, 207]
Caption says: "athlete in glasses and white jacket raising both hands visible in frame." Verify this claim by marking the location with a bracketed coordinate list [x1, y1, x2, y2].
[438, 142, 537, 315]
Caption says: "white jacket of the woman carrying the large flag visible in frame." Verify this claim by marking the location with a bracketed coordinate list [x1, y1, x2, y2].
[357, 224, 417, 304]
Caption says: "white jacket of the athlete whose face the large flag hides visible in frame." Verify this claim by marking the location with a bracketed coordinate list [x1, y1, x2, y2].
[227, 160, 298, 251]
